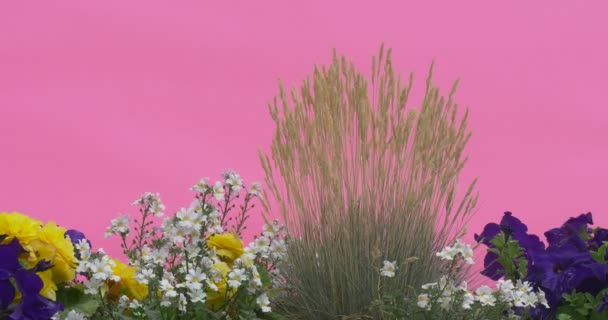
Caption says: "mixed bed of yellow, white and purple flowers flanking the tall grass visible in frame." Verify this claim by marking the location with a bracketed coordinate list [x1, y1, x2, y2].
[0, 171, 608, 320]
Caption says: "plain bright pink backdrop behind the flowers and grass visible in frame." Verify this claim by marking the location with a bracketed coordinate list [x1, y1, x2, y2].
[0, 0, 608, 253]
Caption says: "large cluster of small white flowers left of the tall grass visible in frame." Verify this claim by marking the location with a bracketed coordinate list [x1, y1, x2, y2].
[92, 170, 287, 314]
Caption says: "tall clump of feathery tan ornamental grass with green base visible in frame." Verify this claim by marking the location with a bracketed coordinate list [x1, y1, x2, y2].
[260, 48, 477, 319]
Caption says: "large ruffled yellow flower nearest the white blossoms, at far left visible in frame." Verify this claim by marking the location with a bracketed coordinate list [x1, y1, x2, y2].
[30, 222, 78, 283]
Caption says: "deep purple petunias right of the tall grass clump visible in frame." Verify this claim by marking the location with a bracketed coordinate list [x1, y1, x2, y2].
[475, 212, 608, 317]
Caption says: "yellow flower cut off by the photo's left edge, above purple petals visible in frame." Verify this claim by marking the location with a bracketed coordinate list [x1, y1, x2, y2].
[0, 212, 42, 245]
